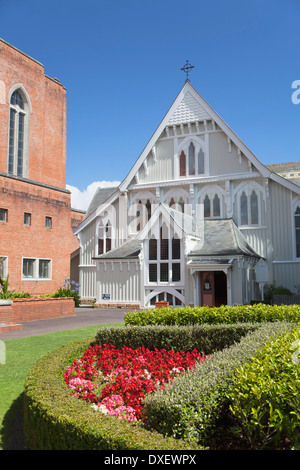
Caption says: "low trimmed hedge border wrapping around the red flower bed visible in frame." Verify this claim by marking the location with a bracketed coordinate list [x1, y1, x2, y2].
[24, 323, 294, 450]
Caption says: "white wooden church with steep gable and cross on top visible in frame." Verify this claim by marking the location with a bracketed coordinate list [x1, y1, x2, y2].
[76, 80, 300, 308]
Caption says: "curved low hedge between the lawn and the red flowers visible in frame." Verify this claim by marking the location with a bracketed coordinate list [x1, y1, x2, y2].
[24, 341, 203, 450]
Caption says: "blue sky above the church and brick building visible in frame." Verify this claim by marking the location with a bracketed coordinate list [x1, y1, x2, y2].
[0, 0, 300, 208]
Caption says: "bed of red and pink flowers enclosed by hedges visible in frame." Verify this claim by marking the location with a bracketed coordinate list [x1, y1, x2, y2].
[64, 344, 206, 422]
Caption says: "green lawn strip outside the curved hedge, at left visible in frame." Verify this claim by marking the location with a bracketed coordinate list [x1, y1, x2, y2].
[0, 323, 124, 450]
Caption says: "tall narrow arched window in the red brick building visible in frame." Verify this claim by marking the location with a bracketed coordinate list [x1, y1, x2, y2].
[8, 90, 28, 176]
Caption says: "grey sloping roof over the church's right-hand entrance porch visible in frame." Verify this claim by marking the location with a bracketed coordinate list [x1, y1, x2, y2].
[188, 219, 260, 258]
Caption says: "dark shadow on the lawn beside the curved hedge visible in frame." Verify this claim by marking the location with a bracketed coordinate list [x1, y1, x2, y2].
[0, 393, 27, 450]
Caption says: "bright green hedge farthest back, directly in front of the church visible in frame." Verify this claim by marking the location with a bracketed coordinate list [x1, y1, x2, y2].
[124, 303, 300, 326]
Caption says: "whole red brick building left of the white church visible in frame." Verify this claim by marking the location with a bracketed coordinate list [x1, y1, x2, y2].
[0, 39, 83, 294]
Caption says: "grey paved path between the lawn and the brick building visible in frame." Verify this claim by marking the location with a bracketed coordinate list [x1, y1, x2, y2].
[0, 307, 127, 341]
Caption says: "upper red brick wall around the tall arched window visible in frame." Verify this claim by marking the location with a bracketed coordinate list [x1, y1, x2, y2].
[0, 40, 66, 188]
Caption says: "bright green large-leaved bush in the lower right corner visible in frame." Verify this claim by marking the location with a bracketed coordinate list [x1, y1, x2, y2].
[228, 328, 300, 449]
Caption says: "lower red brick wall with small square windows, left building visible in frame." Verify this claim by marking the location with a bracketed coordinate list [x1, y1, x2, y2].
[0, 176, 74, 294]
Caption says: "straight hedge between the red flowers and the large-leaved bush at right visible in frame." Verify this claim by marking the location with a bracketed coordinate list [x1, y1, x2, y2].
[143, 322, 295, 445]
